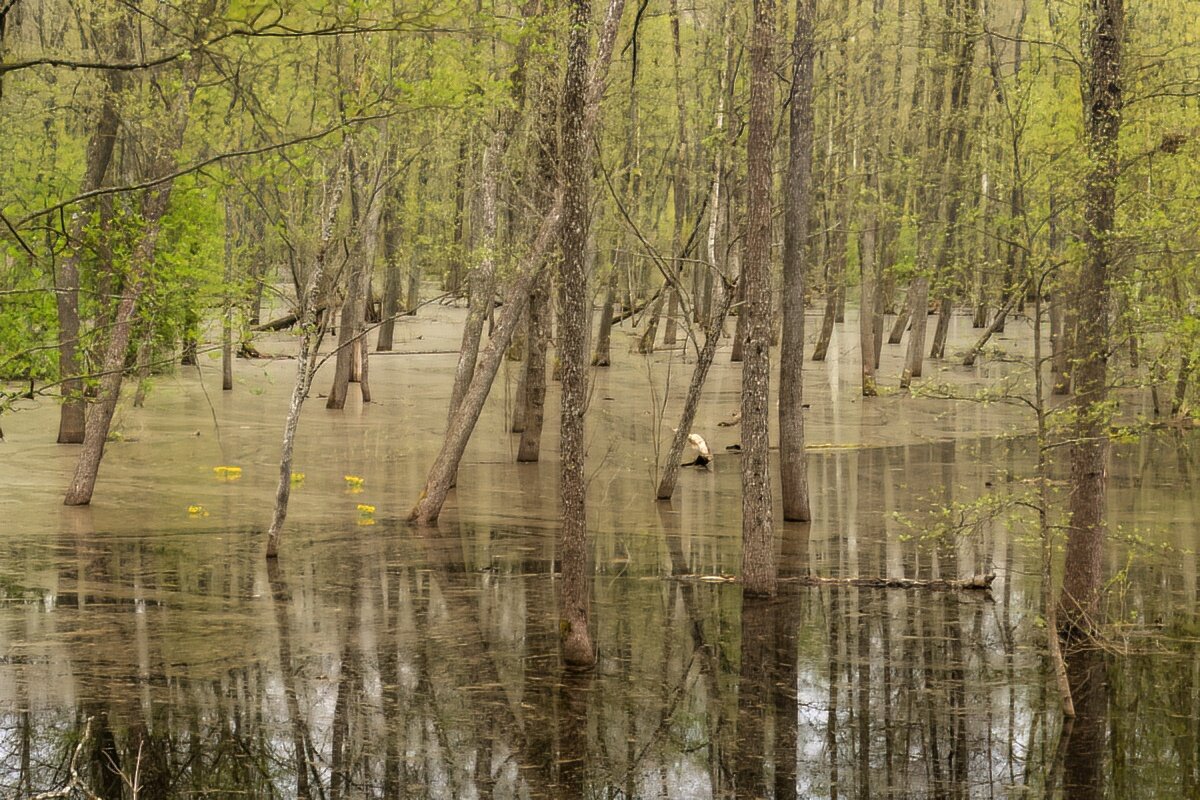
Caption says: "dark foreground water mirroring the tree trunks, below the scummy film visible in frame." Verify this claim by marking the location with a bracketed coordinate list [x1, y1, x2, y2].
[0, 443, 1200, 800]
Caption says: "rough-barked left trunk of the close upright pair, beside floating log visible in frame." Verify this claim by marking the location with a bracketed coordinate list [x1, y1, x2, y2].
[742, 0, 776, 595]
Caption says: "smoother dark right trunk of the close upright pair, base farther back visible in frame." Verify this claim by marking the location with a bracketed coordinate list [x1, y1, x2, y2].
[779, 0, 816, 522]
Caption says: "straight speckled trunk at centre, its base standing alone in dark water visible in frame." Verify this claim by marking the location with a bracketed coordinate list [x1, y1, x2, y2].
[558, 0, 595, 667]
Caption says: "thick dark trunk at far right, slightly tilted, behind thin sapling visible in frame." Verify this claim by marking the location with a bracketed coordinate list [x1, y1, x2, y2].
[1060, 0, 1124, 633]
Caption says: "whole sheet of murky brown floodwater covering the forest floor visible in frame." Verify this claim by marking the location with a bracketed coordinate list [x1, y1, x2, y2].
[0, 307, 1200, 800]
